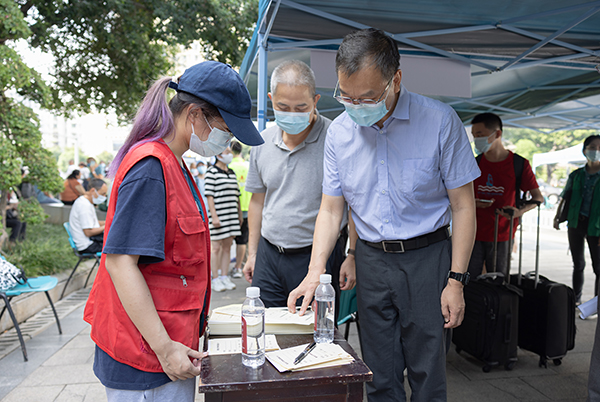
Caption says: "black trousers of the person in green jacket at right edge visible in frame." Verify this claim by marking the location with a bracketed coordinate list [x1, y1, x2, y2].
[568, 215, 600, 302]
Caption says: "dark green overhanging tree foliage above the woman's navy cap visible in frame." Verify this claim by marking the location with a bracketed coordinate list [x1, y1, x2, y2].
[19, 0, 258, 119]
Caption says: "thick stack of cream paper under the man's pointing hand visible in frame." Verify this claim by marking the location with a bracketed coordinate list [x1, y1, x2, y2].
[208, 304, 314, 335]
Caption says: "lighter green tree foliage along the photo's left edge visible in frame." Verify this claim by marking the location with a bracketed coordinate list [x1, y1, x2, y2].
[0, 0, 60, 240]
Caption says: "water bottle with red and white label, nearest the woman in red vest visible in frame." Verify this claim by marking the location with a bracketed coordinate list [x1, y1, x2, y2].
[242, 287, 265, 368]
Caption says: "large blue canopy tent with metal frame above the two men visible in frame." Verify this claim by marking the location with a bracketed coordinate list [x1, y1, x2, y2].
[240, 0, 600, 130]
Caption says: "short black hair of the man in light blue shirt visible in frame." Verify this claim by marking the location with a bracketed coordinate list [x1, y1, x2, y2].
[335, 28, 400, 79]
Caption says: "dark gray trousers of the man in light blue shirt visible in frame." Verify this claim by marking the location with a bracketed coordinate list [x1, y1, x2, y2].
[356, 239, 452, 402]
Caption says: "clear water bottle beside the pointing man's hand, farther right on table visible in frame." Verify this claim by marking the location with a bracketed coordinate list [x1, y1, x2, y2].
[313, 274, 335, 343]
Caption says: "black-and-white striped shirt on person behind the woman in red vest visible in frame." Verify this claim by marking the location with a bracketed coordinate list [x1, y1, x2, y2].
[204, 166, 242, 240]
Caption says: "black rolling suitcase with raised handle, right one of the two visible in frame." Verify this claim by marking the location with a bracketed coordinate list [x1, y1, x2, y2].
[510, 203, 575, 367]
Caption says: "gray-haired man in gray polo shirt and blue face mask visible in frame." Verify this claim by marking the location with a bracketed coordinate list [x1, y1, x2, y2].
[244, 60, 355, 311]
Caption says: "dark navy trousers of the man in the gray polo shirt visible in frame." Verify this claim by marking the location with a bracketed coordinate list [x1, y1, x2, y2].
[252, 236, 346, 314]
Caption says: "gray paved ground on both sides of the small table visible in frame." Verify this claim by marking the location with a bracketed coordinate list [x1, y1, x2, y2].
[0, 213, 596, 402]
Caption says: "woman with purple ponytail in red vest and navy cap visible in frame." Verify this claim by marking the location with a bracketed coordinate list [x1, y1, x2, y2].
[84, 61, 263, 401]
